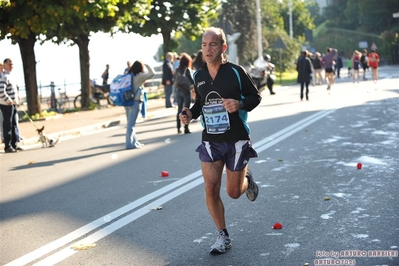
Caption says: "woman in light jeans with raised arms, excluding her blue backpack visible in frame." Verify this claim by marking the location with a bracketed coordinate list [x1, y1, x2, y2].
[124, 61, 155, 149]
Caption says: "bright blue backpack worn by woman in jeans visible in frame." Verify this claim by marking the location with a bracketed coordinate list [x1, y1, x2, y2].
[109, 73, 135, 106]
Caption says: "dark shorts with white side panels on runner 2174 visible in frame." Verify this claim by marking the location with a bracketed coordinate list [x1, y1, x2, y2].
[195, 140, 258, 171]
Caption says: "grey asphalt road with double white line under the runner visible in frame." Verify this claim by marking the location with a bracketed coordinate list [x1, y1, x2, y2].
[0, 67, 399, 266]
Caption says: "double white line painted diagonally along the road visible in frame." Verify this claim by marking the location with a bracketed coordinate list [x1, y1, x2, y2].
[5, 82, 390, 266]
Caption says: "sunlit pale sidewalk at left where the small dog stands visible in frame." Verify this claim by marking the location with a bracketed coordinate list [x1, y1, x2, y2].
[0, 99, 176, 152]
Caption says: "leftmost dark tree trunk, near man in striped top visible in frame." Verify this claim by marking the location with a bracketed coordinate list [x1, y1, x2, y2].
[16, 33, 42, 115]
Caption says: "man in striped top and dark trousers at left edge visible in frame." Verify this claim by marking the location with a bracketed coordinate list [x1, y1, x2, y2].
[0, 58, 19, 153]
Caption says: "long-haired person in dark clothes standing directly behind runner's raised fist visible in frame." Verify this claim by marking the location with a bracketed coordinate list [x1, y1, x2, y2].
[175, 53, 194, 134]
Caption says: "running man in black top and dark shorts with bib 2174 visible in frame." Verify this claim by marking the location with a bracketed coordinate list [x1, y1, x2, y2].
[180, 27, 261, 254]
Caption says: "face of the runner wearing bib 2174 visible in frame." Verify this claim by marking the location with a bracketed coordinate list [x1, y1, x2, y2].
[201, 32, 227, 64]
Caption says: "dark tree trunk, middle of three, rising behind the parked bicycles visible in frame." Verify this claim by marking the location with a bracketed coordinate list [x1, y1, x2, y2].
[73, 34, 91, 108]
